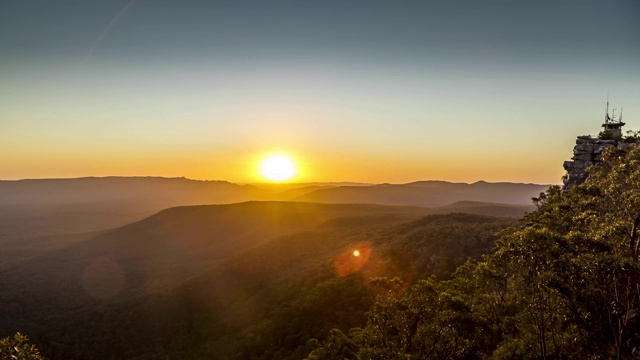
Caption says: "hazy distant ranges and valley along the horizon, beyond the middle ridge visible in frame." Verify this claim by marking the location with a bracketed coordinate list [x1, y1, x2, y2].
[0, 177, 548, 244]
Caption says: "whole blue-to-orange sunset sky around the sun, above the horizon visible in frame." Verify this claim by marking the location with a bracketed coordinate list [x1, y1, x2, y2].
[0, 0, 640, 184]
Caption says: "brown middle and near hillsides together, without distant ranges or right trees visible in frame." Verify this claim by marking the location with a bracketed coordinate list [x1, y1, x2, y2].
[0, 210, 517, 359]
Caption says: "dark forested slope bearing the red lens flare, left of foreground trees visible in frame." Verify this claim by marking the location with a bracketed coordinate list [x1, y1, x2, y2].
[30, 214, 518, 359]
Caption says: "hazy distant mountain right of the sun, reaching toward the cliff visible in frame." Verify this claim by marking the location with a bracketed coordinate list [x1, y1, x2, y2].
[295, 181, 548, 207]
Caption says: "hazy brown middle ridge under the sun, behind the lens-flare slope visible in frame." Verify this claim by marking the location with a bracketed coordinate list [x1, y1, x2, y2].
[0, 202, 428, 348]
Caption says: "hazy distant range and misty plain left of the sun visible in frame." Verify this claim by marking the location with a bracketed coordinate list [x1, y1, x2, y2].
[0, 177, 270, 244]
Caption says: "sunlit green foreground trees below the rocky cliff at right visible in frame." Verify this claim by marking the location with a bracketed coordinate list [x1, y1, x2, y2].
[310, 149, 640, 359]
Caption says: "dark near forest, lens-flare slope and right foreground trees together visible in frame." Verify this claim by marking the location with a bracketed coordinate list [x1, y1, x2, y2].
[0, 149, 640, 359]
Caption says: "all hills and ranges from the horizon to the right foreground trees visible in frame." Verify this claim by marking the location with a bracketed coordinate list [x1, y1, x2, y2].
[0, 177, 547, 359]
